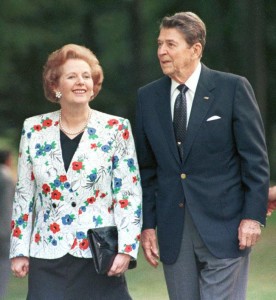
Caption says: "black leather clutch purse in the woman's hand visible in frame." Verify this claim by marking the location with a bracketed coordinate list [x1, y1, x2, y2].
[87, 226, 137, 274]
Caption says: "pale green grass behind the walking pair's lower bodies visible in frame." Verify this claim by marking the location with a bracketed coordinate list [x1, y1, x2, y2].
[5, 212, 276, 300]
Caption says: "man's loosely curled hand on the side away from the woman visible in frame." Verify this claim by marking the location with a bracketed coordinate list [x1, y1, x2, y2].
[238, 219, 261, 250]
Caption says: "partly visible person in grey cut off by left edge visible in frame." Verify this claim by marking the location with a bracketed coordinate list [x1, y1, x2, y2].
[0, 150, 14, 299]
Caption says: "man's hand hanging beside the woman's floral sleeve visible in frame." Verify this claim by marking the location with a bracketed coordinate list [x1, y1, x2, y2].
[141, 229, 159, 268]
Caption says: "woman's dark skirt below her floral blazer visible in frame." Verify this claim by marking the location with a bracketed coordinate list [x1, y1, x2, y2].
[27, 254, 131, 300]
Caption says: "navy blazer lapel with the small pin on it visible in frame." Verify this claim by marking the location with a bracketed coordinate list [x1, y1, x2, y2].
[183, 64, 215, 162]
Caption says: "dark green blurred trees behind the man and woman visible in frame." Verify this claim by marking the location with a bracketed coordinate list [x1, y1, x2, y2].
[0, 0, 276, 178]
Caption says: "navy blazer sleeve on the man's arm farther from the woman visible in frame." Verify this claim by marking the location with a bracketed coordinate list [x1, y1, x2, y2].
[233, 78, 269, 224]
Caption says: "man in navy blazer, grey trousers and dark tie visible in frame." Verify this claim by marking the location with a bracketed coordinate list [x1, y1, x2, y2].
[136, 12, 269, 300]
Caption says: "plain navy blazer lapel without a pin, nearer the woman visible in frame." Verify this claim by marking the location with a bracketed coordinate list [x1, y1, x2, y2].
[155, 77, 180, 163]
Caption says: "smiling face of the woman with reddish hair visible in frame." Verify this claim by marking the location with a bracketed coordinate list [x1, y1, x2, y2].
[56, 59, 93, 105]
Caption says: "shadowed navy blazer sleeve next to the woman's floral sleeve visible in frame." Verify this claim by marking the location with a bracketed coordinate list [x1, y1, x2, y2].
[135, 90, 157, 229]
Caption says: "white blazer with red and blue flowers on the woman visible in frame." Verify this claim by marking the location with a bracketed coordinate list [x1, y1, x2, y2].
[10, 110, 142, 259]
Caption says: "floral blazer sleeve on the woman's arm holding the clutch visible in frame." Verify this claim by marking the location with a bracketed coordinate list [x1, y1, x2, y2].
[112, 119, 142, 259]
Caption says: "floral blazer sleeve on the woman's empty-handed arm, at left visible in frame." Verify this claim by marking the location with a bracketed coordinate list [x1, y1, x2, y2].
[10, 121, 35, 258]
